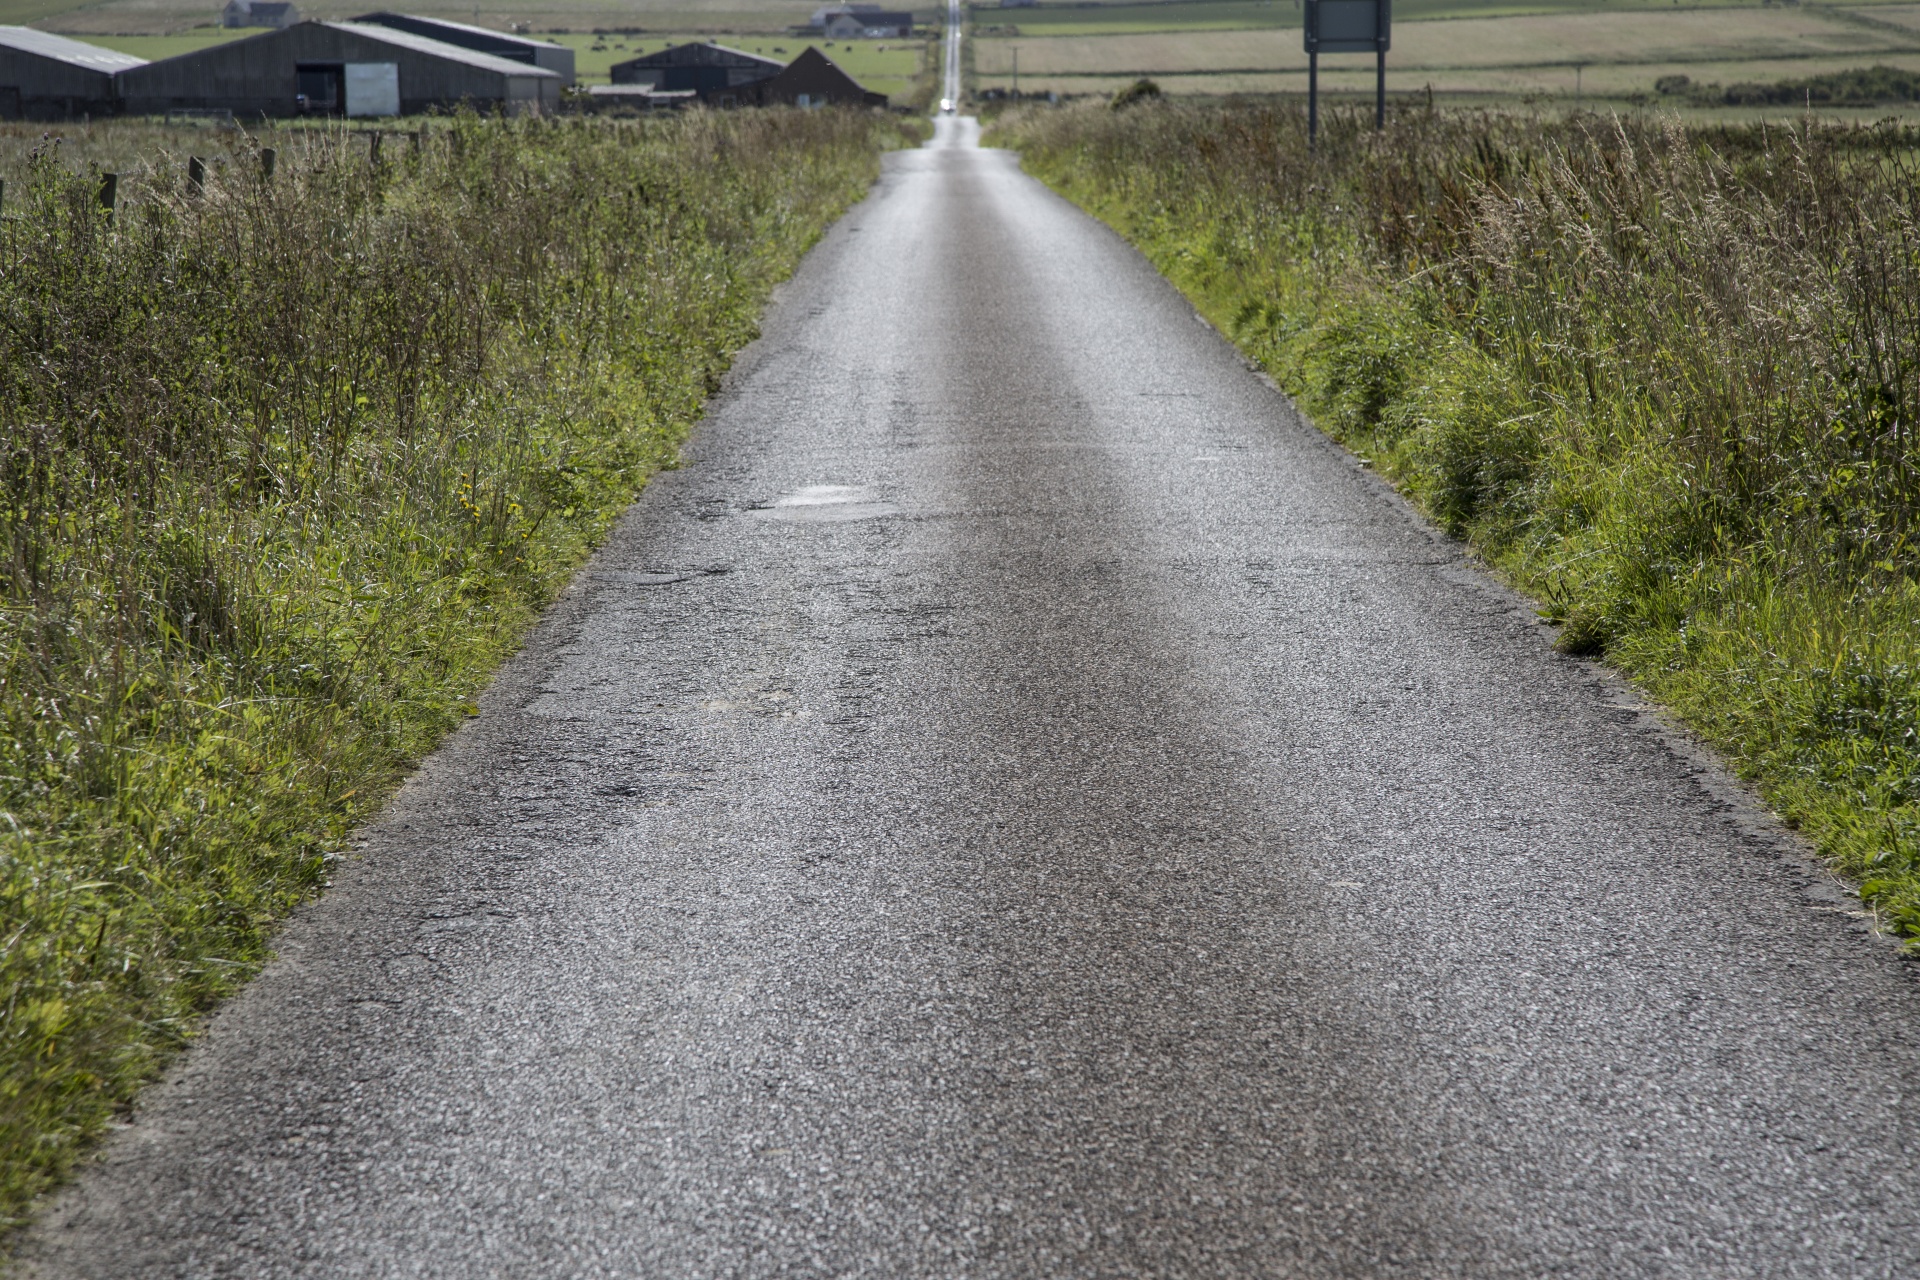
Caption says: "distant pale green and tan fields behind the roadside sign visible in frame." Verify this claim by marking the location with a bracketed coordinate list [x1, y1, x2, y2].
[972, 0, 1920, 102]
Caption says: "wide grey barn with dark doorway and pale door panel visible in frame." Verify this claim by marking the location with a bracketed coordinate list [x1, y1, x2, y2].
[115, 23, 561, 117]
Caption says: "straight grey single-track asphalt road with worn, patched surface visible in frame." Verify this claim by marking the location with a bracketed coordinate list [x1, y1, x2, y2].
[25, 117, 1920, 1280]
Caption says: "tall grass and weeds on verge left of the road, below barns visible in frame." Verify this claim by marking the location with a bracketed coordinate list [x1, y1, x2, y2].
[0, 111, 902, 1224]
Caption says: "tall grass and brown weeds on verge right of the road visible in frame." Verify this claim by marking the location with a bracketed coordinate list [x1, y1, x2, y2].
[989, 98, 1920, 940]
